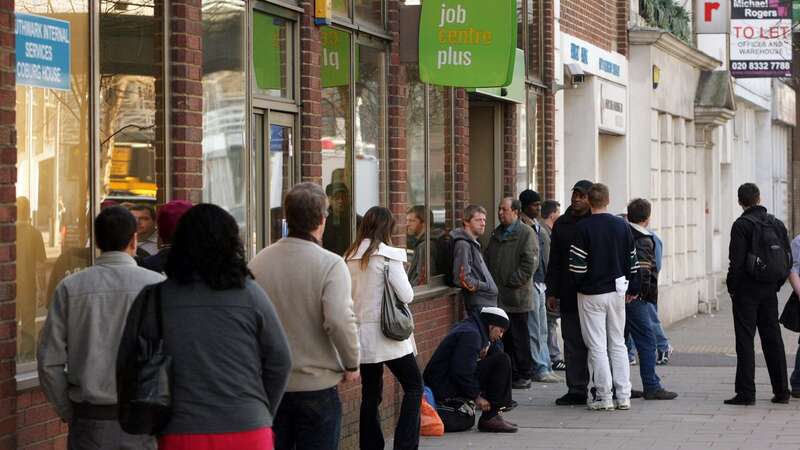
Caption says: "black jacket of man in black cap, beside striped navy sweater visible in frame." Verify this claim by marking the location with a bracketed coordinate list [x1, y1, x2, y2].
[545, 206, 592, 313]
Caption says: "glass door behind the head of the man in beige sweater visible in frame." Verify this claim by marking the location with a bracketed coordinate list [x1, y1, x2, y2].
[252, 109, 296, 251]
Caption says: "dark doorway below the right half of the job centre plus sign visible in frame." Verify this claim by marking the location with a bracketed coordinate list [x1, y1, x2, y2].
[468, 101, 503, 247]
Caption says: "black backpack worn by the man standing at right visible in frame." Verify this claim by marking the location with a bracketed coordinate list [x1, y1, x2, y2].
[743, 214, 792, 283]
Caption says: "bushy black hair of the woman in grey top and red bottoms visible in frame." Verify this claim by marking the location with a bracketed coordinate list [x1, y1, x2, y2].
[164, 203, 252, 290]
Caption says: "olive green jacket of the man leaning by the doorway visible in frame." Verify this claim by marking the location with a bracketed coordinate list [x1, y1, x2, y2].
[485, 221, 539, 313]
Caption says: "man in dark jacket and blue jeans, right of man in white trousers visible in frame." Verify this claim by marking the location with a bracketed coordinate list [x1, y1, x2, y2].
[625, 198, 678, 400]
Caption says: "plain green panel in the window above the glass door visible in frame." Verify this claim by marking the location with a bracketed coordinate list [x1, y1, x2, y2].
[253, 11, 285, 90]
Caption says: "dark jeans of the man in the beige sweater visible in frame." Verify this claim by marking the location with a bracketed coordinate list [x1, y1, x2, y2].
[272, 387, 342, 450]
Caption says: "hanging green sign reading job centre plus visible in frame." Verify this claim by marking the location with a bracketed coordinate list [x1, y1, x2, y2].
[419, 0, 517, 87]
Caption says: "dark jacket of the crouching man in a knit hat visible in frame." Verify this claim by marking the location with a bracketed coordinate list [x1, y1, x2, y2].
[423, 316, 489, 400]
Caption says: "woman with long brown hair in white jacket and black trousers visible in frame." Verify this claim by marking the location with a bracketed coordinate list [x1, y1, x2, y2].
[345, 206, 422, 450]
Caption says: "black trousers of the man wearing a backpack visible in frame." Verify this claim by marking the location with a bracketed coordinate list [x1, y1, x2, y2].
[732, 291, 789, 398]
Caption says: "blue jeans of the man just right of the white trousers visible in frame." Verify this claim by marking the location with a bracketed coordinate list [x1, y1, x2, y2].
[625, 300, 661, 392]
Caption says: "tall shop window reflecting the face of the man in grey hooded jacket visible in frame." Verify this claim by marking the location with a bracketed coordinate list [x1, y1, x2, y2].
[404, 65, 451, 286]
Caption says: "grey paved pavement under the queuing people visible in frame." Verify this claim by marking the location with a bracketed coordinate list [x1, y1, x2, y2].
[420, 289, 800, 450]
